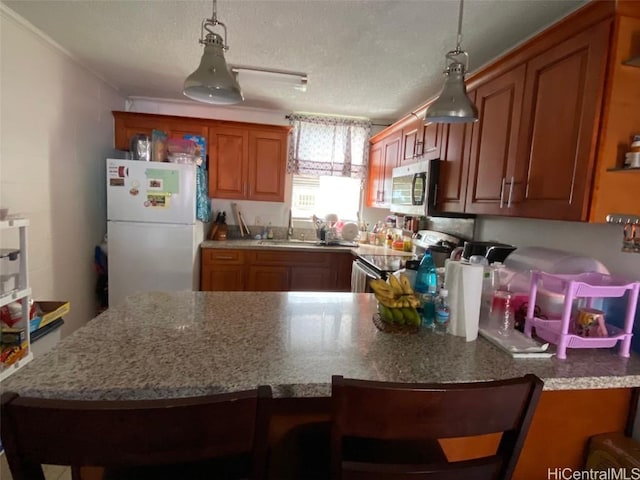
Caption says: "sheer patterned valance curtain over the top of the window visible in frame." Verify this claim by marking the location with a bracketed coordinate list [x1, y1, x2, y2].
[287, 113, 371, 179]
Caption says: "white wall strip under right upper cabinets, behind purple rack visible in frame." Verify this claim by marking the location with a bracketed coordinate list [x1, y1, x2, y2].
[475, 217, 640, 280]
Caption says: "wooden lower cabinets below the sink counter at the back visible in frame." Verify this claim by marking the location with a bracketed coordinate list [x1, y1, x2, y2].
[200, 248, 353, 292]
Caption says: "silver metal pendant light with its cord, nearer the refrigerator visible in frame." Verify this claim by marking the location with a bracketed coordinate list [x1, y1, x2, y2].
[182, 0, 244, 105]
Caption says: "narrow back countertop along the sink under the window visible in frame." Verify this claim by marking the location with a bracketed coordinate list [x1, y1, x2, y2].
[200, 239, 413, 257]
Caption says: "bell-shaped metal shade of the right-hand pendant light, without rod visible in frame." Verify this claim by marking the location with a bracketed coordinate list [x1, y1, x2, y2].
[425, 63, 478, 123]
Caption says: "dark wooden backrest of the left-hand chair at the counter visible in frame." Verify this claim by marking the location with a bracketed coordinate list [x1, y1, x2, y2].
[0, 386, 272, 480]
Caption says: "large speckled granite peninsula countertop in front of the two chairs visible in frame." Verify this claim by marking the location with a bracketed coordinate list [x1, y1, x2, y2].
[2, 292, 640, 399]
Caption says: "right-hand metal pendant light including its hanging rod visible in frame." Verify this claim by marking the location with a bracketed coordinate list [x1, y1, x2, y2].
[424, 0, 478, 123]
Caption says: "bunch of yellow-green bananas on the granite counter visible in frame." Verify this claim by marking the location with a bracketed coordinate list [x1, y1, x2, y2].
[369, 274, 420, 325]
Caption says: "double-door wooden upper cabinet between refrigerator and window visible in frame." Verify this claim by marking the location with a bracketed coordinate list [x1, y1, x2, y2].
[209, 127, 287, 202]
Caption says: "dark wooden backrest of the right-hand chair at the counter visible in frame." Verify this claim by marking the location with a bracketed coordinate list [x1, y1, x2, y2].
[331, 375, 543, 480]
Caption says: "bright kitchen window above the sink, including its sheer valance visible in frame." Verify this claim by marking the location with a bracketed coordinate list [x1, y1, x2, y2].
[287, 114, 371, 220]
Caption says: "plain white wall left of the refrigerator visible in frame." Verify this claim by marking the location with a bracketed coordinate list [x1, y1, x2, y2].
[0, 5, 125, 335]
